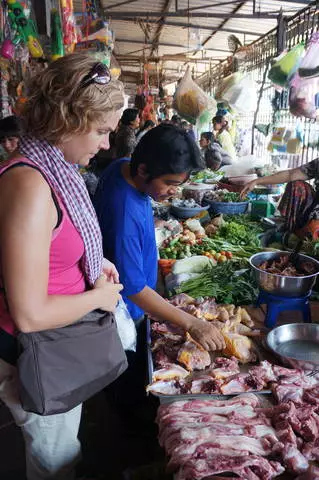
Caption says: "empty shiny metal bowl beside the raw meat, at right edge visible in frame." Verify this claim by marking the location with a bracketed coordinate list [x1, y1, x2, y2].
[267, 323, 319, 370]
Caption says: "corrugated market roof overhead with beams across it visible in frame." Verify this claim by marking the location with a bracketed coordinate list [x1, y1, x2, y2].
[74, 0, 311, 87]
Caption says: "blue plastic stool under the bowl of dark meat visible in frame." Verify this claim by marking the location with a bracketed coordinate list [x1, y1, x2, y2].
[256, 290, 311, 328]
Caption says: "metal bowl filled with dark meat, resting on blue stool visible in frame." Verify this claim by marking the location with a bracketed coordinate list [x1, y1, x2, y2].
[249, 251, 319, 297]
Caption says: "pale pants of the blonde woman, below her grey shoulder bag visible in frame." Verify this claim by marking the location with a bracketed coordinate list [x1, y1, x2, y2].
[0, 359, 82, 480]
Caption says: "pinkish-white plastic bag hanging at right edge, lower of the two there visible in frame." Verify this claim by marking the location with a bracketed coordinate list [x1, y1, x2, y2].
[289, 73, 319, 119]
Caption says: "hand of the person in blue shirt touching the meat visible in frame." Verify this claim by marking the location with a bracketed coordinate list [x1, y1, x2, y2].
[188, 317, 226, 350]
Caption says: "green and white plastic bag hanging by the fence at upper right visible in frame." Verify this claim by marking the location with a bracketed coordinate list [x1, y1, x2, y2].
[268, 42, 305, 87]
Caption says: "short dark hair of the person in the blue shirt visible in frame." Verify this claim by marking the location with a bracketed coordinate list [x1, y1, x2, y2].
[131, 123, 205, 181]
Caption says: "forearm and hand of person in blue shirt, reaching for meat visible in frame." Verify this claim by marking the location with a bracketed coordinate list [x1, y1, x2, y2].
[129, 287, 225, 350]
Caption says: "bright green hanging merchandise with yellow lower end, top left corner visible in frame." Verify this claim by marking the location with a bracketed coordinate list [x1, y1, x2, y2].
[7, 0, 44, 58]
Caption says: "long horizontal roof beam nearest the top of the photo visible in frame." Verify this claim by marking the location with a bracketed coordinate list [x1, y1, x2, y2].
[104, 9, 278, 19]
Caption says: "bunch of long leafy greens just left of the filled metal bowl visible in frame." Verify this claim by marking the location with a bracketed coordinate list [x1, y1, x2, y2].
[173, 262, 258, 305]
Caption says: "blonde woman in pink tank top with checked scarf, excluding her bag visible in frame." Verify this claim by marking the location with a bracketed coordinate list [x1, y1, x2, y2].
[0, 54, 124, 480]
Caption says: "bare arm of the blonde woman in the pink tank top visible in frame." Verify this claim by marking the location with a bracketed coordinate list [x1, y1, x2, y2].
[0, 167, 122, 332]
